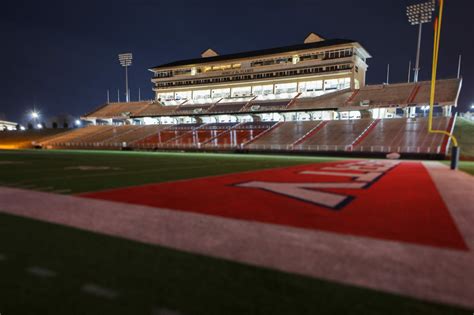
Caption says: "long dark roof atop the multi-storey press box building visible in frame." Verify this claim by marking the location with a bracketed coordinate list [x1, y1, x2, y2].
[150, 39, 357, 70]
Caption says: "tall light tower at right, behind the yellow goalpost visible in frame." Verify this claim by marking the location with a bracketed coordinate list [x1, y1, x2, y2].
[407, 0, 436, 82]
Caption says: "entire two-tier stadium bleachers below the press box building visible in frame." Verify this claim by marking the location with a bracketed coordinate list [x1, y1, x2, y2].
[15, 79, 461, 154]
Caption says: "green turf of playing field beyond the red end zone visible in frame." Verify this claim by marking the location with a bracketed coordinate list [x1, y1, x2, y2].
[0, 150, 342, 193]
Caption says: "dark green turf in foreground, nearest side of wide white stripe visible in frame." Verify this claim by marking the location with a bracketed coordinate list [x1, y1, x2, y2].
[0, 214, 471, 315]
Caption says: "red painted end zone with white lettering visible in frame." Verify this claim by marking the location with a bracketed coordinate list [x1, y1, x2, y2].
[82, 161, 467, 250]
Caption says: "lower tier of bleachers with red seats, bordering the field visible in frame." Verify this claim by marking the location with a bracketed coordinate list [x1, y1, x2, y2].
[36, 117, 452, 154]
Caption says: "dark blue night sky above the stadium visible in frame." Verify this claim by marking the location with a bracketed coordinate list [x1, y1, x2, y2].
[0, 0, 474, 121]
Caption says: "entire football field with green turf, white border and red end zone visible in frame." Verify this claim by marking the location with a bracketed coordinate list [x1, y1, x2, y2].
[0, 150, 474, 315]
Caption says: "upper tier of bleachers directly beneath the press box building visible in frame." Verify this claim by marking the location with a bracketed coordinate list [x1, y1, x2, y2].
[80, 79, 462, 119]
